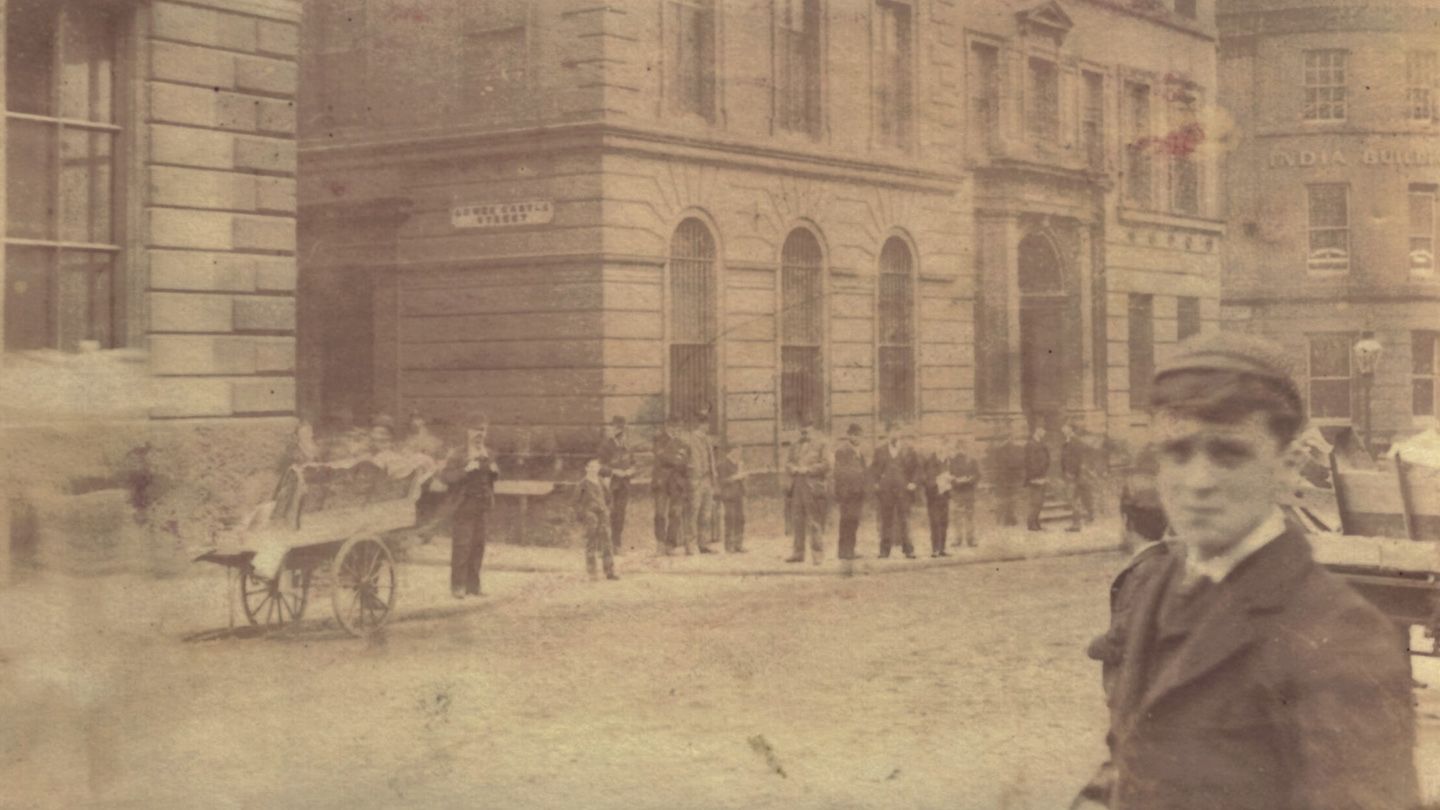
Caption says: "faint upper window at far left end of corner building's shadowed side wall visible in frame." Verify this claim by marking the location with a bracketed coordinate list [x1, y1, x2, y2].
[302, 0, 369, 130]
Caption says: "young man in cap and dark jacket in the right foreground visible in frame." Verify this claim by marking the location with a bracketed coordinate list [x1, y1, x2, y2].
[1080, 333, 1418, 810]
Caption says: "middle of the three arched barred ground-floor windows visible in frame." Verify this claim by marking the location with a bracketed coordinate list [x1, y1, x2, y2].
[780, 228, 825, 428]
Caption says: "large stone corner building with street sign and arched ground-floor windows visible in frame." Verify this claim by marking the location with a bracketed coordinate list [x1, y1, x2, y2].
[300, 0, 1221, 470]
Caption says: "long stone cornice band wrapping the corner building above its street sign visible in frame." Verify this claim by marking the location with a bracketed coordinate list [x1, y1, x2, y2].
[300, 123, 965, 193]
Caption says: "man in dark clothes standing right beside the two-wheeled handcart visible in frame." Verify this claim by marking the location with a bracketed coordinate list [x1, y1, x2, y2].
[439, 414, 500, 600]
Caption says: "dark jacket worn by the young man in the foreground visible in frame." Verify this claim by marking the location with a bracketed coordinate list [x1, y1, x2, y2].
[1110, 526, 1418, 810]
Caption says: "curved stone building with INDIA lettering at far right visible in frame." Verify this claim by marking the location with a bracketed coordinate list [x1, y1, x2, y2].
[1220, 0, 1440, 445]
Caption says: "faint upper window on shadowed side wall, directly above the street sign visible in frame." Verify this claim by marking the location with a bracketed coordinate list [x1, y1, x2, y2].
[461, 0, 527, 112]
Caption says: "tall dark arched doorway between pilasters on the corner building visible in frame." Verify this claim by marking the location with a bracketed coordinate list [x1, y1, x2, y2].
[1018, 233, 1068, 412]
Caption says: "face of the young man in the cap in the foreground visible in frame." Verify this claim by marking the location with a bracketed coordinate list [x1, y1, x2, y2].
[1155, 411, 1292, 559]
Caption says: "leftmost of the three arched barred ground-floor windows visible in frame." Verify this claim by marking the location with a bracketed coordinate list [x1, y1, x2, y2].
[670, 219, 717, 419]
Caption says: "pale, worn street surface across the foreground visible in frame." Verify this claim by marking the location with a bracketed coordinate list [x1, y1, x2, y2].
[0, 518, 1440, 809]
